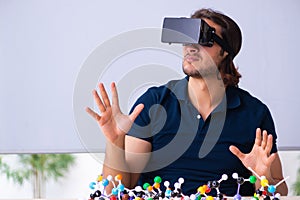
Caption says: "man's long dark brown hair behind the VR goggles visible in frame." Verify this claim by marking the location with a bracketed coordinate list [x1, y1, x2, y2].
[191, 9, 242, 87]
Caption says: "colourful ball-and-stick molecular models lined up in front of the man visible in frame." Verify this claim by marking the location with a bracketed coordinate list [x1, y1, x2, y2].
[89, 168, 287, 200]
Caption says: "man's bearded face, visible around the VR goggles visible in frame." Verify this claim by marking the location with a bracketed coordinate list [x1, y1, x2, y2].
[182, 19, 227, 77]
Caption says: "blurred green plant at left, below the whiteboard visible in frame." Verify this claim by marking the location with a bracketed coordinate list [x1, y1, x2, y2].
[0, 154, 75, 198]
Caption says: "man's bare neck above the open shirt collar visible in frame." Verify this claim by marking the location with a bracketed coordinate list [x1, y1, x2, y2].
[188, 77, 225, 119]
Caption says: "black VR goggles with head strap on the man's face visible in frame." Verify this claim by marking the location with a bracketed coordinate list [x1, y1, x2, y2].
[161, 17, 233, 55]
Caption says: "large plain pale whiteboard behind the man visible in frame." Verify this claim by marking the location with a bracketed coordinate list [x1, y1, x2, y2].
[0, 0, 300, 153]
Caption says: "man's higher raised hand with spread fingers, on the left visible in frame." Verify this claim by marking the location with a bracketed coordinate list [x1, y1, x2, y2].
[86, 83, 144, 143]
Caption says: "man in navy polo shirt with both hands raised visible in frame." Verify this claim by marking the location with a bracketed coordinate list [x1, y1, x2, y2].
[87, 9, 287, 196]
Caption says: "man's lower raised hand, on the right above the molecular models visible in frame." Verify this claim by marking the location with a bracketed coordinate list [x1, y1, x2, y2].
[229, 128, 276, 177]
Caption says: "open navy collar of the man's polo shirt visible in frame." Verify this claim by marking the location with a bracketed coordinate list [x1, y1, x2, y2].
[173, 76, 241, 111]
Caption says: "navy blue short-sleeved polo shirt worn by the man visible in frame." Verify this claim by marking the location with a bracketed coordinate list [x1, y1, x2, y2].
[128, 77, 277, 196]
